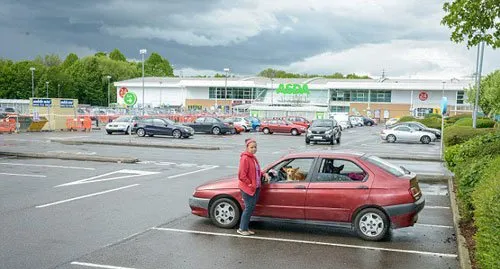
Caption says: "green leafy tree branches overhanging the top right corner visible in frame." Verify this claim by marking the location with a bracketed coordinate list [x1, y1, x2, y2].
[441, 0, 500, 48]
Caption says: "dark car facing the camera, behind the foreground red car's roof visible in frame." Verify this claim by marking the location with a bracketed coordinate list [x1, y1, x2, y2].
[306, 119, 342, 145]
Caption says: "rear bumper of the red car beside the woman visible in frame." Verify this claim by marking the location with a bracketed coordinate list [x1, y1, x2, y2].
[384, 197, 425, 229]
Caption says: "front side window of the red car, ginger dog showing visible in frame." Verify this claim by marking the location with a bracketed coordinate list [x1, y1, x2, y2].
[268, 158, 314, 184]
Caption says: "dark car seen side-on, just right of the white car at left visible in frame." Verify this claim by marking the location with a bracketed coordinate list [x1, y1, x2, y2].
[136, 118, 194, 138]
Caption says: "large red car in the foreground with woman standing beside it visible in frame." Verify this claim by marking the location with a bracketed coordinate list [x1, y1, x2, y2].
[189, 152, 425, 241]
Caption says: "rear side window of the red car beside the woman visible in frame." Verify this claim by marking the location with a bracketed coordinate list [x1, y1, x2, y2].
[312, 159, 368, 182]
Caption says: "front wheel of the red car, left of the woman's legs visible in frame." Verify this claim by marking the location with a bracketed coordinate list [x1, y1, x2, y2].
[210, 198, 241, 229]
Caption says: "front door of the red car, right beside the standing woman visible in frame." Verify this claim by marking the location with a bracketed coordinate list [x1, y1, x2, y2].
[254, 158, 316, 220]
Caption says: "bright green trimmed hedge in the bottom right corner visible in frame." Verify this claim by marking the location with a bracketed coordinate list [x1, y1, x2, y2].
[472, 157, 500, 268]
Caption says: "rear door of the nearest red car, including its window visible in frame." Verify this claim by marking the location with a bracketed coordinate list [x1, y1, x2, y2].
[305, 158, 374, 222]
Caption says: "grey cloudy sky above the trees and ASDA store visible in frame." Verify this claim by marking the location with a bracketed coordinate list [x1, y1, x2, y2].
[0, 0, 500, 79]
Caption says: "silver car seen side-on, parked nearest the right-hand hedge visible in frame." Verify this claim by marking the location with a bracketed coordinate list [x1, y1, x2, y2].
[380, 125, 436, 144]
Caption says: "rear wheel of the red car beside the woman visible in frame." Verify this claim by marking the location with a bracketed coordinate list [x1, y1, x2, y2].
[354, 208, 390, 241]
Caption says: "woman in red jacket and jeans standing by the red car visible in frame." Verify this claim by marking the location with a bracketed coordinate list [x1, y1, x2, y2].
[236, 138, 268, 235]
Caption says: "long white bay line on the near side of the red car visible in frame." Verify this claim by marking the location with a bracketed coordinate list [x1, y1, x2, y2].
[153, 228, 457, 258]
